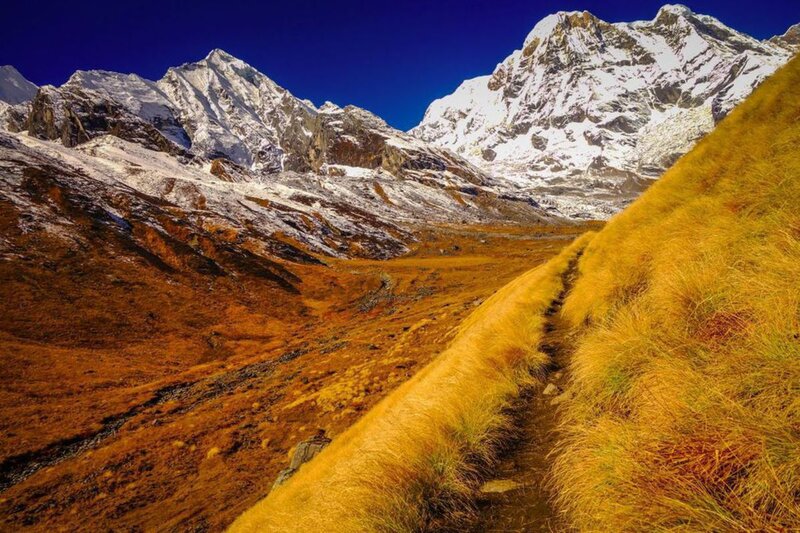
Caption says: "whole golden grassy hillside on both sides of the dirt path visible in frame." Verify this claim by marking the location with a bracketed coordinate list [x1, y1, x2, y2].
[231, 53, 800, 531]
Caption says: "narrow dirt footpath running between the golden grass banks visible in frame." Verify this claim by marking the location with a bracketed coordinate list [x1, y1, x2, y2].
[470, 256, 579, 533]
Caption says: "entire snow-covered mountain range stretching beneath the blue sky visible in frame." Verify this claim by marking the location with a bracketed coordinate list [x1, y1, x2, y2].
[0, 2, 800, 234]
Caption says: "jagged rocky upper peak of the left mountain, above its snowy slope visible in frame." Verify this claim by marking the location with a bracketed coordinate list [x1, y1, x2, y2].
[36, 50, 494, 185]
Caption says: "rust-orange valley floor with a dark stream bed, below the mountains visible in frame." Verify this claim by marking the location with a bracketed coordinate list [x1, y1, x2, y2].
[0, 221, 590, 531]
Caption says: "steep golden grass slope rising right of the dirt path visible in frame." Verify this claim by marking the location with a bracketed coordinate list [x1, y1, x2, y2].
[555, 54, 800, 531]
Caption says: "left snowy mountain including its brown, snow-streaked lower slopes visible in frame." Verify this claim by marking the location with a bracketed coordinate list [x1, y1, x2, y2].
[0, 50, 549, 272]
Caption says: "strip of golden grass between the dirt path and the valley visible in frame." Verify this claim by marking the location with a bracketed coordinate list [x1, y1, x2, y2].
[230, 235, 589, 532]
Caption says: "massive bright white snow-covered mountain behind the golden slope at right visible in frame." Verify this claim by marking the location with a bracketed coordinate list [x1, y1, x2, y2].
[411, 5, 797, 217]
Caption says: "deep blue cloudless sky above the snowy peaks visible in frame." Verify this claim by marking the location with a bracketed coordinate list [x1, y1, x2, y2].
[0, 0, 800, 129]
